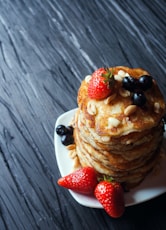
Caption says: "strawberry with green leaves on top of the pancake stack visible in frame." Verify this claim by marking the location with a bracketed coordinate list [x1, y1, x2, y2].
[88, 68, 114, 100]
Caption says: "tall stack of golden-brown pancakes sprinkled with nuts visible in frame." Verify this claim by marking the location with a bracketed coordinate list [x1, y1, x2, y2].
[71, 66, 165, 188]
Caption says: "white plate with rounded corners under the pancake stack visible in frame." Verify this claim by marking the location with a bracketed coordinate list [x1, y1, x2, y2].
[54, 109, 166, 208]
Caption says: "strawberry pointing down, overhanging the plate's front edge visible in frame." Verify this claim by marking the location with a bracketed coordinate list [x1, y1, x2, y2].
[94, 180, 125, 218]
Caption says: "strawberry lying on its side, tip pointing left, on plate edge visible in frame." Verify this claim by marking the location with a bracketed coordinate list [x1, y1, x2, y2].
[58, 167, 98, 195]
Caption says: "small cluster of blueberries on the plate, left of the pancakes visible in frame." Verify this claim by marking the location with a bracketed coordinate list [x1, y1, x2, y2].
[56, 125, 74, 146]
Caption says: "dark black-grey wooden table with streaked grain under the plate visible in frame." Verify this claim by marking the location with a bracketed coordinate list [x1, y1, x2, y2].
[0, 0, 166, 230]
